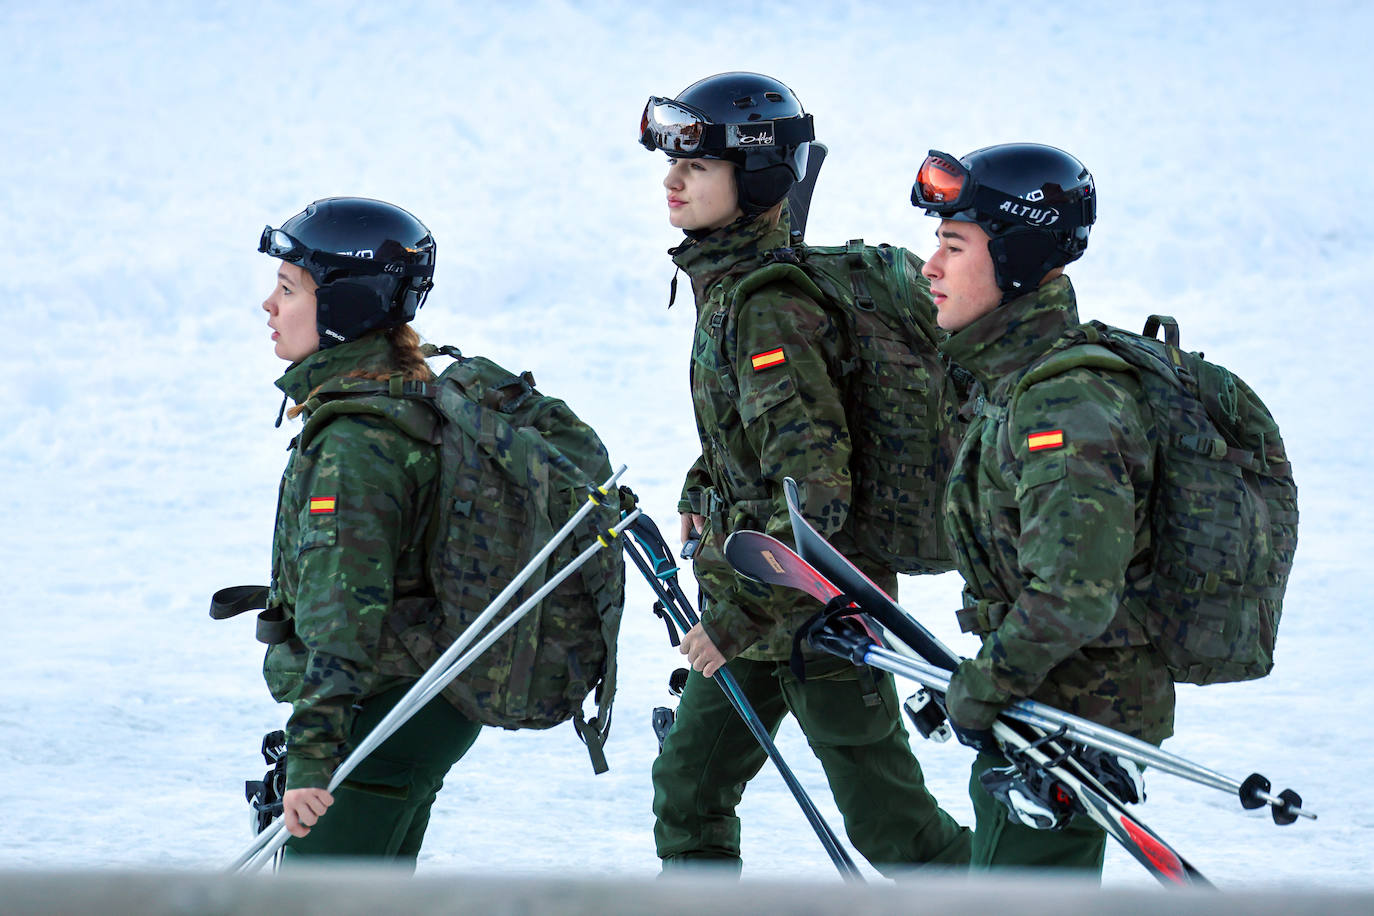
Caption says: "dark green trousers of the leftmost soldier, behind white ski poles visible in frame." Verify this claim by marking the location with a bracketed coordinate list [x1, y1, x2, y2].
[282, 684, 482, 868]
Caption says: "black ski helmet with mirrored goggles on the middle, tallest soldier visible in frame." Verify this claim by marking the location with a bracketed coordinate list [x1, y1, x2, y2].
[639, 71, 816, 216]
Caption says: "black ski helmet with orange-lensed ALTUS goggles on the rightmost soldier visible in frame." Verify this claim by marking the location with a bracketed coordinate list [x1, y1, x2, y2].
[911, 143, 1098, 298]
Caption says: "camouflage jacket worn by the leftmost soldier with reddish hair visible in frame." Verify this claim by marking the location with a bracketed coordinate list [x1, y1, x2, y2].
[262, 335, 438, 788]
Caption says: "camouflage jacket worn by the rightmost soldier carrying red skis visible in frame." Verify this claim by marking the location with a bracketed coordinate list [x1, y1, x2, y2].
[944, 277, 1173, 742]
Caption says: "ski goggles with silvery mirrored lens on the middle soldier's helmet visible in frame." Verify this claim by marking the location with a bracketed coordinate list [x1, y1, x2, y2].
[639, 96, 816, 158]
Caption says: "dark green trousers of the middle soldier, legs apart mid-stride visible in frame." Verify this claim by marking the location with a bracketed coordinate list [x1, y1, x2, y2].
[653, 658, 969, 872]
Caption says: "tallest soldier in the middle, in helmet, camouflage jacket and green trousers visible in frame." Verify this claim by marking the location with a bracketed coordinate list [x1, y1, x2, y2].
[642, 73, 969, 871]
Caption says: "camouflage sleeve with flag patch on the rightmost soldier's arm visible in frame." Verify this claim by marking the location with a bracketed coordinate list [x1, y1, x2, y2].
[951, 368, 1153, 706]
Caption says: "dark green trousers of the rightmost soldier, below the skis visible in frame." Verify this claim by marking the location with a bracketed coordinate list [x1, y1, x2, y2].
[969, 754, 1107, 878]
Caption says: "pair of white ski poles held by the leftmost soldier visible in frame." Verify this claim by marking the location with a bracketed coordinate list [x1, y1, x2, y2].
[228, 464, 639, 872]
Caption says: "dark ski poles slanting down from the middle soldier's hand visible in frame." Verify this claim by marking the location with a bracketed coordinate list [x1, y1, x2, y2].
[624, 515, 863, 882]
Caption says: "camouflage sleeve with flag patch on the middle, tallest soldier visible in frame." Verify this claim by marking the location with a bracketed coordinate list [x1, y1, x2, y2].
[705, 286, 853, 656]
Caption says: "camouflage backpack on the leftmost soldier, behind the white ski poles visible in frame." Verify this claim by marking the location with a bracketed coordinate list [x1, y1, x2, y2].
[302, 345, 625, 773]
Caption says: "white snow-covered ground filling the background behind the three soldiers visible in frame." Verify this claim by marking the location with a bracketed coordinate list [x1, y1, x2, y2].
[0, 0, 1374, 887]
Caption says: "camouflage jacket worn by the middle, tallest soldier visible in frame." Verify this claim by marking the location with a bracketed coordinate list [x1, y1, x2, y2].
[672, 210, 881, 659]
